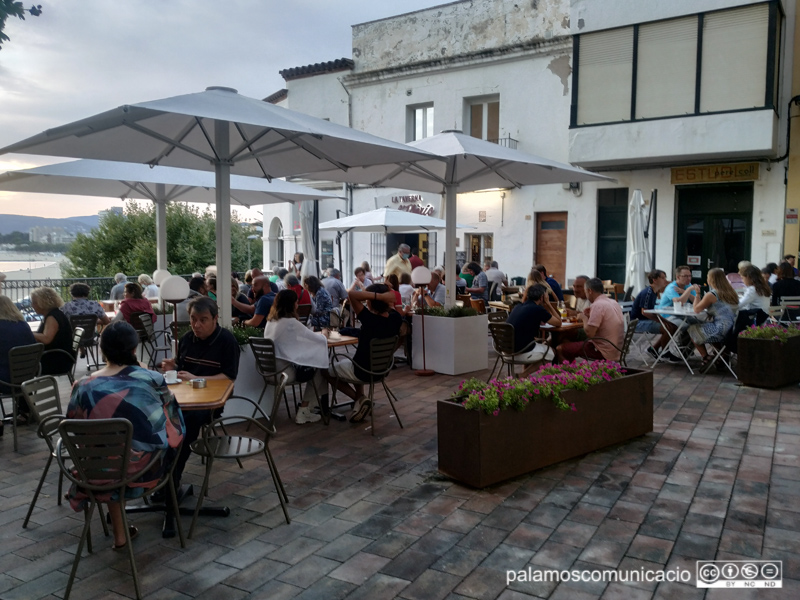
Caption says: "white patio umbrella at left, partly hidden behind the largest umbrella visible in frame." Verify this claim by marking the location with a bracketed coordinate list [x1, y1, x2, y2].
[0, 159, 339, 270]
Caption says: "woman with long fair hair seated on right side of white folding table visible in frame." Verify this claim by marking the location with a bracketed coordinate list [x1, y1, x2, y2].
[688, 268, 739, 369]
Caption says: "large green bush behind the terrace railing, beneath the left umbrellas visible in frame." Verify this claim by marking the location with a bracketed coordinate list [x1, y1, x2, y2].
[64, 202, 262, 277]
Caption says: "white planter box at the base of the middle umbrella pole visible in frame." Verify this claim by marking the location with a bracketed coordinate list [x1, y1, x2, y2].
[413, 315, 489, 375]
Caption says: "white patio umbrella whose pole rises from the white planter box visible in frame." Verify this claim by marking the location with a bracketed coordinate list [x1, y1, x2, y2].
[306, 131, 613, 306]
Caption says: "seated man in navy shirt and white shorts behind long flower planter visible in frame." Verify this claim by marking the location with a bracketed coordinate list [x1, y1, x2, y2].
[506, 285, 561, 377]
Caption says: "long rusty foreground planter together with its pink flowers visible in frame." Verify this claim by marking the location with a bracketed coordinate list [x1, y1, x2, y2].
[437, 361, 653, 487]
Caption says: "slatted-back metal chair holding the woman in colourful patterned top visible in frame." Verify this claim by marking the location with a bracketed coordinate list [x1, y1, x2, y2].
[55, 419, 183, 600]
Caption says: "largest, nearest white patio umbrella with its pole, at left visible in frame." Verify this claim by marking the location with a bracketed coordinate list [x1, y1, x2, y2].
[0, 87, 438, 325]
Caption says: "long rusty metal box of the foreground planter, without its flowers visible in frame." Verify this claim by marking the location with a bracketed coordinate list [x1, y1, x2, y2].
[437, 369, 653, 488]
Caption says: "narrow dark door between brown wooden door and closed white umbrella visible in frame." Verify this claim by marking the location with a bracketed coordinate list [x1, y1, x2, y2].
[595, 188, 628, 283]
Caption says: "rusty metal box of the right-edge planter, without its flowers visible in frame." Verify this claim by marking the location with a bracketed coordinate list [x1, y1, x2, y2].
[736, 336, 800, 388]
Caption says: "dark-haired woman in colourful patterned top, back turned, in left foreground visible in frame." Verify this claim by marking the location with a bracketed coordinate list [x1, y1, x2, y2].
[67, 322, 185, 550]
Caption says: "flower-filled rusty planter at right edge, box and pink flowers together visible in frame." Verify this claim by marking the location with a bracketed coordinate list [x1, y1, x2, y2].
[736, 323, 800, 388]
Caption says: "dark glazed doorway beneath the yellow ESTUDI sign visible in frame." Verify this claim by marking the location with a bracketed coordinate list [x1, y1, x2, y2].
[675, 184, 753, 283]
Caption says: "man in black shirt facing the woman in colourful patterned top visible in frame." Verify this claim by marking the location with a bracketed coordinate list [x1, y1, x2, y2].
[161, 296, 241, 489]
